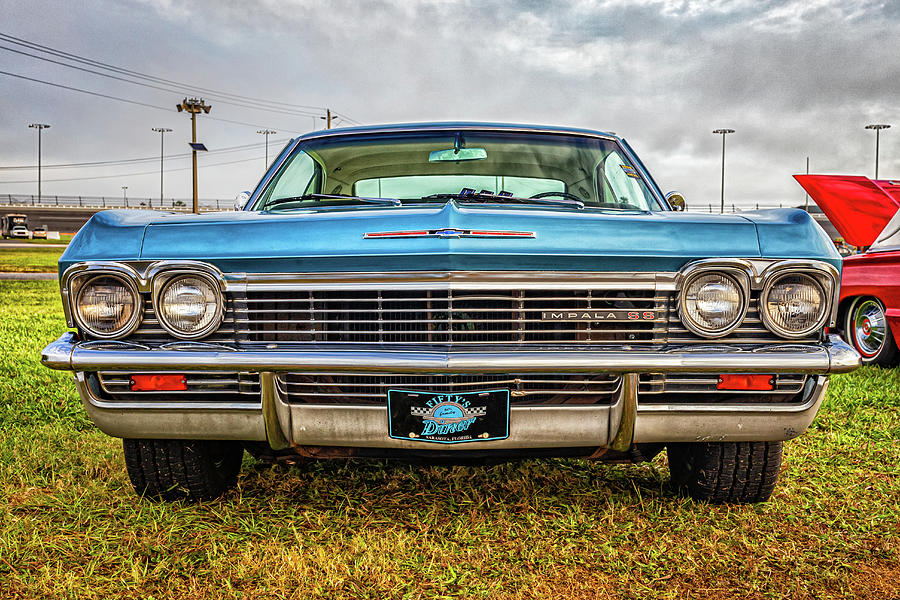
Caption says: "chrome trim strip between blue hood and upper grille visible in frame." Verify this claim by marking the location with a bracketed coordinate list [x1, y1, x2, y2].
[225, 271, 676, 291]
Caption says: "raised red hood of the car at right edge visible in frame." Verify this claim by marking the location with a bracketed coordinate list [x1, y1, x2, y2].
[794, 175, 900, 246]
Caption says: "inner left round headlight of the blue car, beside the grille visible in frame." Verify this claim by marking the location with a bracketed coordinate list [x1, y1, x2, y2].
[156, 274, 222, 339]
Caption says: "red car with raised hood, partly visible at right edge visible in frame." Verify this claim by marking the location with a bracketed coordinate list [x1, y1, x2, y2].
[794, 175, 900, 365]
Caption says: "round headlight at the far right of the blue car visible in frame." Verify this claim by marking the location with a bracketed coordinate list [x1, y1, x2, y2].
[760, 272, 828, 338]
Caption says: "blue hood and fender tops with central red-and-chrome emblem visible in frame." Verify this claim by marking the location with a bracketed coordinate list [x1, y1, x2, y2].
[61, 202, 839, 272]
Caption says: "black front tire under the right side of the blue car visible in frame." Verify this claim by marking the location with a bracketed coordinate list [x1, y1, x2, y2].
[666, 442, 782, 504]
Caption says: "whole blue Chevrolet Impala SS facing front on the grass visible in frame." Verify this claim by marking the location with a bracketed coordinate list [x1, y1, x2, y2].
[42, 123, 860, 502]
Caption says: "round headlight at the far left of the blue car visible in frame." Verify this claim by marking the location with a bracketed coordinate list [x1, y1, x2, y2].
[73, 274, 141, 339]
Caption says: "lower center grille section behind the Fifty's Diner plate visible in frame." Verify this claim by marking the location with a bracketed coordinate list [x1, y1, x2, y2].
[275, 373, 622, 405]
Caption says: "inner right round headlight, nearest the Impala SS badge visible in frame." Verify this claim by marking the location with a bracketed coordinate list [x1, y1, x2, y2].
[681, 271, 747, 338]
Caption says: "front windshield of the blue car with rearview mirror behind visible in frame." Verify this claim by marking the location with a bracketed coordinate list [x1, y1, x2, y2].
[255, 130, 661, 211]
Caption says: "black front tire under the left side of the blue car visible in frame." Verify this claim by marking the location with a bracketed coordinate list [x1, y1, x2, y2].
[122, 440, 244, 502]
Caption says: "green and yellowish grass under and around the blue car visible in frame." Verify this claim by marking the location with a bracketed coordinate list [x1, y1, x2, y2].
[0, 281, 900, 599]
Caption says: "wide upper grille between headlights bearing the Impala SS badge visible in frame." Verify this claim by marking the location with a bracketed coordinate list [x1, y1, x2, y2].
[234, 289, 668, 345]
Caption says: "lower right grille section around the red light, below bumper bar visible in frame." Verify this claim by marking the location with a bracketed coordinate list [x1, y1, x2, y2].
[638, 373, 809, 404]
